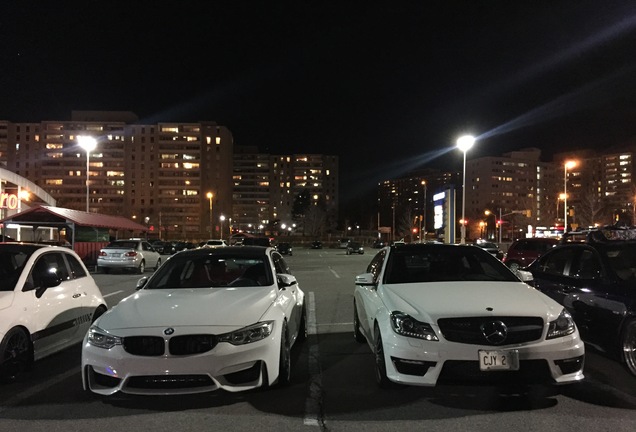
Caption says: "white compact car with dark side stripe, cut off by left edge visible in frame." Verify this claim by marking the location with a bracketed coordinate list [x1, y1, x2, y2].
[0, 243, 106, 381]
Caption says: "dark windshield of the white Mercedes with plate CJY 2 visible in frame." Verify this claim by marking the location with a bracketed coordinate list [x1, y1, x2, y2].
[384, 245, 519, 284]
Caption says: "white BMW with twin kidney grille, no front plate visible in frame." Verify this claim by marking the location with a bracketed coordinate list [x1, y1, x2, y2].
[82, 246, 307, 395]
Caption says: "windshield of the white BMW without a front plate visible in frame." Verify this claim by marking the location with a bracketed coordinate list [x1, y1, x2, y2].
[145, 254, 273, 289]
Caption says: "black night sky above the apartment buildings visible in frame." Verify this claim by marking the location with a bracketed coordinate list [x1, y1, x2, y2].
[0, 0, 636, 213]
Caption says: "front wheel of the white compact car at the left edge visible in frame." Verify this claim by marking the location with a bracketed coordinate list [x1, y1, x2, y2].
[0, 328, 33, 382]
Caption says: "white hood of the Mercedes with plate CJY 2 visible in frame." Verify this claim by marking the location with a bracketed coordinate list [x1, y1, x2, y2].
[379, 281, 563, 322]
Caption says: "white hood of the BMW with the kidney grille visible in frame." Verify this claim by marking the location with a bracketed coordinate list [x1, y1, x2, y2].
[98, 286, 276, 330]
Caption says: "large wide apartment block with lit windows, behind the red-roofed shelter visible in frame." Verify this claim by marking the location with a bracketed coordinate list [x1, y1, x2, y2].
[0, 111, 234, 239]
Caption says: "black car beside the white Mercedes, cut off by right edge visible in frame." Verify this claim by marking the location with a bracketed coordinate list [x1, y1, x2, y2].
[528, 227, 636, 376]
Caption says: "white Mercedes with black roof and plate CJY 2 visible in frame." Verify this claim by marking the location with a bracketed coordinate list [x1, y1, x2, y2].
[353, 244, 585, 387]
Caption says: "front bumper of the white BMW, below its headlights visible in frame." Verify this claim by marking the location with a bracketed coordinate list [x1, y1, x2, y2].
[82, 330, 280, 395]
